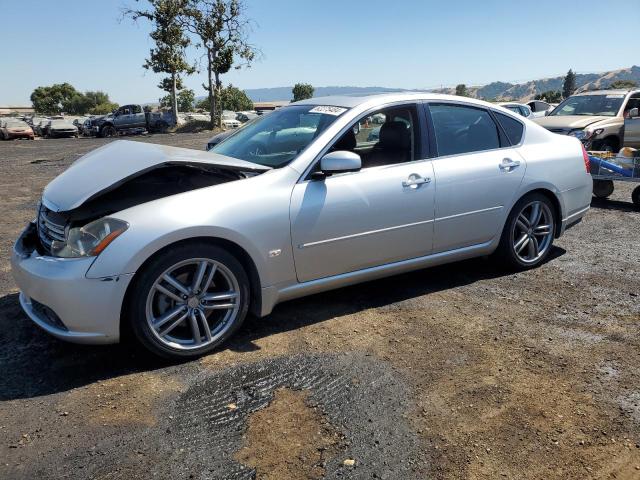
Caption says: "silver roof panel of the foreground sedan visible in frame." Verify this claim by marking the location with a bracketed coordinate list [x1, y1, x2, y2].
[292, 92, 498, 108]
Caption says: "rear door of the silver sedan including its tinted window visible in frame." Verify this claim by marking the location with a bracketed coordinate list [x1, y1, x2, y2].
[428, 102, 526, 253]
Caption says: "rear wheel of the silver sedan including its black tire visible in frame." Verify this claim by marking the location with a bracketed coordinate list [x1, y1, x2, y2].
[494, 193, 557, 271]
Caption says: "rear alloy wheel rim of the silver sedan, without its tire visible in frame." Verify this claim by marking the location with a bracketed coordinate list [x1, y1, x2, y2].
[511, 200, 553, 264]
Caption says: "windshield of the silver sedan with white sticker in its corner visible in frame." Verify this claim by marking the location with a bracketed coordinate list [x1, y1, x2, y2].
[210, 105, 347, 168]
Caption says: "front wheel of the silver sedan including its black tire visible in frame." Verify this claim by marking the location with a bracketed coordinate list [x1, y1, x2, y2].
[126, 243, 250, 360]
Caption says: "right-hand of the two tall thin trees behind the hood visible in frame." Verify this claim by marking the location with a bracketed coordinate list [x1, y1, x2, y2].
[185, 0, 258, 127]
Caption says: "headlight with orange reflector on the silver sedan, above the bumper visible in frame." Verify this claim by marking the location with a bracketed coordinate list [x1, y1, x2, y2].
[51, 217, 129, 258]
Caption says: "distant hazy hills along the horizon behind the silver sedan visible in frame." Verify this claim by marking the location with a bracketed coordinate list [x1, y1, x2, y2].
[197, 65, 640, 102]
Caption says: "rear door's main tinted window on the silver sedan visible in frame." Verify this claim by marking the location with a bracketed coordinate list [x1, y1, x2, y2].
[429, 104, 501, 156]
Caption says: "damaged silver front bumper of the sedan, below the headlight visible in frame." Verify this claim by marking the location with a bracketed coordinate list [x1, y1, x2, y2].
[11, 222, 133, 344]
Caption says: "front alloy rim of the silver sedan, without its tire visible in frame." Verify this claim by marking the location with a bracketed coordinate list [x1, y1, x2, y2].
[146, 258, 241, 350]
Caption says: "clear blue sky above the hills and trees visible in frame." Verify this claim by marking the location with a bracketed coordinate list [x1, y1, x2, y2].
[0, 0, 640, 106]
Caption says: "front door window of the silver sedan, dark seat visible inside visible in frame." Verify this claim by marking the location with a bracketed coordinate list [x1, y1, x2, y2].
[329, 105, 420, 169]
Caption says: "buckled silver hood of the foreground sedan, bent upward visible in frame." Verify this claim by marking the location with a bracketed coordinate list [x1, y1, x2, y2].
[42, 140, 270, 212]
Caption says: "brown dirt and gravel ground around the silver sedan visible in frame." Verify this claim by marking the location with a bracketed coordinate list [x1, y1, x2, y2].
[0, 133, 640, 480]
